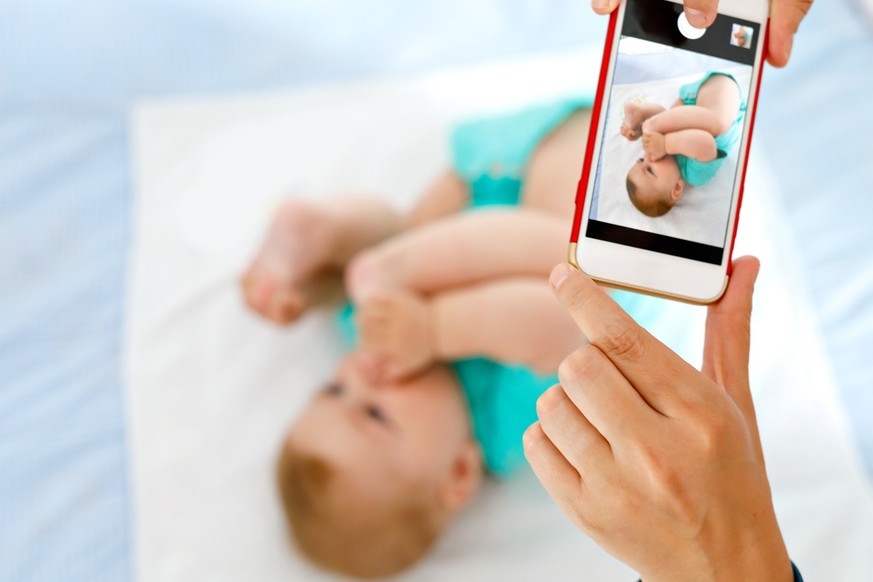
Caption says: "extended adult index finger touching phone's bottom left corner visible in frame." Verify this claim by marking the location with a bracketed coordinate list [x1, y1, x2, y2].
[549, 264, 704, 416]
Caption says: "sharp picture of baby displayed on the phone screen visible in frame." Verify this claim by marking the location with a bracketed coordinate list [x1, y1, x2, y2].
[589, 36, 752, 248]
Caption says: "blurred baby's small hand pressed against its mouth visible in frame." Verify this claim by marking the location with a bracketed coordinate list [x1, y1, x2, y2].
[358, 291, 434, 380]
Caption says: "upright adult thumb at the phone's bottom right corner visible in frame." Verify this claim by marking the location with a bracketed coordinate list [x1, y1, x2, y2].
[702, 257, 760, 418]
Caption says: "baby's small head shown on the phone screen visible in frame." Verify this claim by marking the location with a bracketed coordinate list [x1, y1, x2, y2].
[627, 156, 685, 217]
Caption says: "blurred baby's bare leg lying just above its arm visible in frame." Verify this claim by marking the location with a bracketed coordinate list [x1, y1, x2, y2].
[346, 208, 568, 302]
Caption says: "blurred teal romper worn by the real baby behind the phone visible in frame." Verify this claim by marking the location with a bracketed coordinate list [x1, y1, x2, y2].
[338, 99, 664, 477]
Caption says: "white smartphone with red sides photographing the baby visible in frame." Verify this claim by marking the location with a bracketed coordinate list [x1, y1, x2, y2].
[569, 0, 769, 304]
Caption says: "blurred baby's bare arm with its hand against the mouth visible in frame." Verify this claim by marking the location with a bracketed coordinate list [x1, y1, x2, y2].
[358, 277, 585, 379]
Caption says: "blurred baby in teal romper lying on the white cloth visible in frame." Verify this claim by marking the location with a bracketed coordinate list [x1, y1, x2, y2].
[242, 102, 608, 577]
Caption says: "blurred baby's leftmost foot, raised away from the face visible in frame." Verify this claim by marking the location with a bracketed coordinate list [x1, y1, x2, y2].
[242, 200, 336, 325]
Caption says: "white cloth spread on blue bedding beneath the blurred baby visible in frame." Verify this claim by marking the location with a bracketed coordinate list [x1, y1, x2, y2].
[125, 49, 873, 582]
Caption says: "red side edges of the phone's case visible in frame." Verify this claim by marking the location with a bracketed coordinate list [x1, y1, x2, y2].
[570, 9, 770, 276]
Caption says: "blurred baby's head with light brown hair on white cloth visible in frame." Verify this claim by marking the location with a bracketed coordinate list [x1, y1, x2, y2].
[277, 354, 482, 578]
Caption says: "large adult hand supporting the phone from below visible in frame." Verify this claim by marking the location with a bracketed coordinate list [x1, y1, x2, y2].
[525, 257, 794, 582]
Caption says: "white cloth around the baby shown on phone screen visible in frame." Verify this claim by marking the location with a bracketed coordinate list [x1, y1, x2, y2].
[596, 67, 750, 248]
